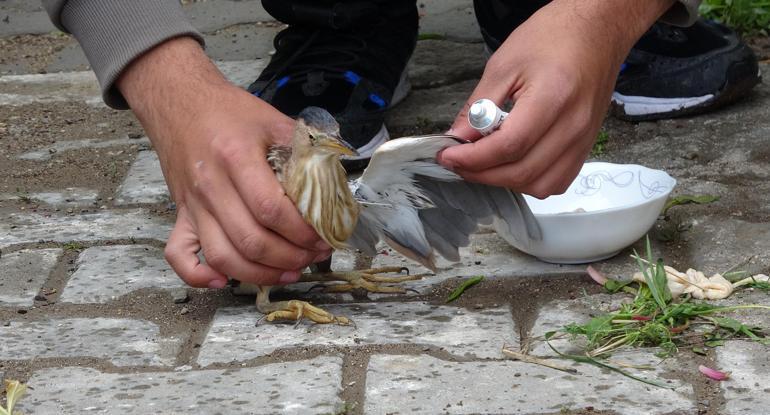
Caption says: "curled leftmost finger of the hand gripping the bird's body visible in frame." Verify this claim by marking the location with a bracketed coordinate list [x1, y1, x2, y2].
[164, 207, 227, 288]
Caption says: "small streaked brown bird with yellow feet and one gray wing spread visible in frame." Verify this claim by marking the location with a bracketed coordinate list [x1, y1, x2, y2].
[244, 107, 541, 324]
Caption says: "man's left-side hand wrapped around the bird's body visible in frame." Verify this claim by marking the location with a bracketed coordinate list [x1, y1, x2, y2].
[118, 38, 330, 288]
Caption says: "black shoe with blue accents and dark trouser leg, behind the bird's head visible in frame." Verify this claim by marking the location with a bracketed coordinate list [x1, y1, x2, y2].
[249, 0, 417, 171]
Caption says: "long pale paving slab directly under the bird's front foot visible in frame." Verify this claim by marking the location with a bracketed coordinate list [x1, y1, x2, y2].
[198, 302, 514, 366]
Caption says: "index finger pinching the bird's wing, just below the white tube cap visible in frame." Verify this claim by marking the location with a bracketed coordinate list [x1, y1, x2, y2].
[439, 85, 563, 172]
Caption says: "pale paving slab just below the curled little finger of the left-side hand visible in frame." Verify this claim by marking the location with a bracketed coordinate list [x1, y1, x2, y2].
[59, 245, 186, 304]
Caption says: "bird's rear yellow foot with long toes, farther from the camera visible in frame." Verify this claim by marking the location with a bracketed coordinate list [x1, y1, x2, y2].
[303, 267, 430, 294]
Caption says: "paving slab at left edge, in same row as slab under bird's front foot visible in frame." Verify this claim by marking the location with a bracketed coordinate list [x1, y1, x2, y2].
[0, 317, 186, 366]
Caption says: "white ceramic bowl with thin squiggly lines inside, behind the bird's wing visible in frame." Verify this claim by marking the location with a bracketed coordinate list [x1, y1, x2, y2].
[516, 162, 676, 264]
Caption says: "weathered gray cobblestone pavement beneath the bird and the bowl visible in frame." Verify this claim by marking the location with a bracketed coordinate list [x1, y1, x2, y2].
[0, 0, 770, 414]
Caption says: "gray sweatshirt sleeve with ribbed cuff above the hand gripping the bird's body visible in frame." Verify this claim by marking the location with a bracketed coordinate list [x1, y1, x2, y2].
[43, 0, 203, 109]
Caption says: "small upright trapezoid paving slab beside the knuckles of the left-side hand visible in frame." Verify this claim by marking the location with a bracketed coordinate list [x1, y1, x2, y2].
[115, 151, 170, 206]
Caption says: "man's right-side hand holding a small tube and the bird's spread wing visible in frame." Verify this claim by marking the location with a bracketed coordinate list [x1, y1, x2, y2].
[439, 0, 673, 198]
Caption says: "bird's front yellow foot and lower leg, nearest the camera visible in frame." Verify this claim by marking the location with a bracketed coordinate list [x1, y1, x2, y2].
[257, 285, 351, 326]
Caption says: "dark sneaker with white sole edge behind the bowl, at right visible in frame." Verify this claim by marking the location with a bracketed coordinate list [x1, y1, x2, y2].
[611, 19, 760, 121]
